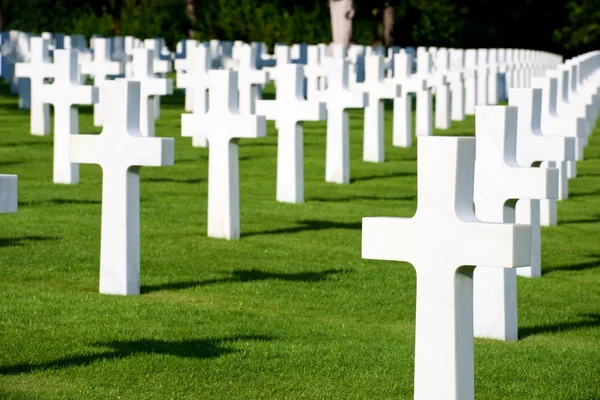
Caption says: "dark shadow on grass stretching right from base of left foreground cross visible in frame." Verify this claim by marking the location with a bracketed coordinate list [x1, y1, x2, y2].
[140, 269, 355, 294]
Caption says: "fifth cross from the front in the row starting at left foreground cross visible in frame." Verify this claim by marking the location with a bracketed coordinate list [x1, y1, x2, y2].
[353, 55, 401, 162]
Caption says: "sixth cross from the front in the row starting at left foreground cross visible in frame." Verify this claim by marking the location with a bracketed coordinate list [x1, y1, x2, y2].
[392, 51, 430, 147]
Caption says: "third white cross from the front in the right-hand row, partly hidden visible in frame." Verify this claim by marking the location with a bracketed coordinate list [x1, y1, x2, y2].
[508, 88, 575, 278]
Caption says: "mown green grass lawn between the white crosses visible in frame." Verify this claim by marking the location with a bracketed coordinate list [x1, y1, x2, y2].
[0, 82, 600, 400]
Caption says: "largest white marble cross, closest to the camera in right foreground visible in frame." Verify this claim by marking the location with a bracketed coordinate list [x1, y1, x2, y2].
[362, 137, 530, 400]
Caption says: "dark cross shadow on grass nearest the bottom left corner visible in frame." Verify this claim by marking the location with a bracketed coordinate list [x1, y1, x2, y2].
[0, 335, 273, 375]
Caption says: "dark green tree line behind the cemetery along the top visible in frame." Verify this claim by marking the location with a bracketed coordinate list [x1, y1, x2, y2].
[0, 0, 600, 57]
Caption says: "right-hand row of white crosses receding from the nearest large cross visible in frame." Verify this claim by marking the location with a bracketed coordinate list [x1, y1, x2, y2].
[362, 52, 600, 400]
